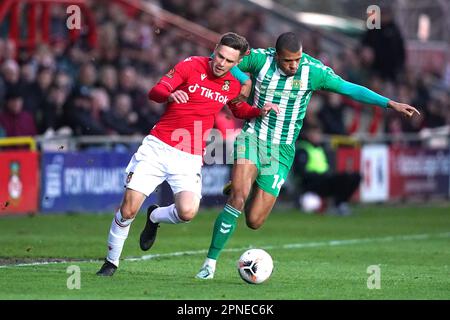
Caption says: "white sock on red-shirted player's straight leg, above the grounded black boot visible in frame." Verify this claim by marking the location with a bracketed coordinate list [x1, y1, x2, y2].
[106, 209, 134, 267]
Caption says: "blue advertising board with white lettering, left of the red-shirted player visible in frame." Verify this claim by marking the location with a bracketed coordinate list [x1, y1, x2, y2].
[40, 151, 157, 213]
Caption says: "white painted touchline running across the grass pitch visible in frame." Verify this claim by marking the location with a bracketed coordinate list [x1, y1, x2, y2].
[0, 232, 450, 269]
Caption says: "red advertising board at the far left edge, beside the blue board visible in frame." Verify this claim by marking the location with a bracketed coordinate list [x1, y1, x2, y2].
[0, 151, 39, 215]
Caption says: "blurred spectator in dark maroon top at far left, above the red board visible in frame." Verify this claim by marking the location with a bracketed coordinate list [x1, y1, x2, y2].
[0, 87, 36, 137]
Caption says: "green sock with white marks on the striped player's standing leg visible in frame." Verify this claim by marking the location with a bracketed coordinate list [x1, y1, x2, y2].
[207, 204, 241, 260]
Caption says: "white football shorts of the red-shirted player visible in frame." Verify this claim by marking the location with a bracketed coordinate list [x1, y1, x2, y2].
[125, 135, 202, 199]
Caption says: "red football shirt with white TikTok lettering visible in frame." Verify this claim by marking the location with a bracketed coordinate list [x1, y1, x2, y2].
[149, 57, 248, 155]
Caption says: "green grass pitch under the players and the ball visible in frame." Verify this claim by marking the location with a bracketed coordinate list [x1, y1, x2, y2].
[0, 206, 450, 300]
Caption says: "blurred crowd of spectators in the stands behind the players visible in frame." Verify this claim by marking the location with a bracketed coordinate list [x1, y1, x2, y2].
[0, 0, 450, 142]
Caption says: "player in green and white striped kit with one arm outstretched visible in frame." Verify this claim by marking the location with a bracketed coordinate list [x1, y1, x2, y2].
[197, 32, 419, 279]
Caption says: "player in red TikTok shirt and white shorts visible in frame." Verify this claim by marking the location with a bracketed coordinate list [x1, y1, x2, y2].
[97, 33, 278, 276]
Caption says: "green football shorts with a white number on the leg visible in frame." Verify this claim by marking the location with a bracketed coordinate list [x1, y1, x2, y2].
[234, 131, 295, 197]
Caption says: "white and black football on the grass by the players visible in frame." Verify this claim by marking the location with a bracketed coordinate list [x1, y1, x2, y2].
[237, 249, 273, 284]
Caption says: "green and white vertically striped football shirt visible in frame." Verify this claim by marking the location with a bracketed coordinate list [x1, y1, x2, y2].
[238, 48, 343, 144]
